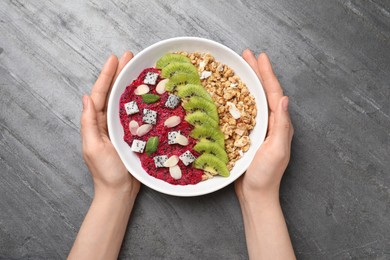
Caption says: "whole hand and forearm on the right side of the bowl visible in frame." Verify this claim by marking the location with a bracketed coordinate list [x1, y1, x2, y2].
[235, 50, 295, 259]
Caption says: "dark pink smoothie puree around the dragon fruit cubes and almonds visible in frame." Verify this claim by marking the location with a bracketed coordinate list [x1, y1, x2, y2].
[119, 68, 203, 185]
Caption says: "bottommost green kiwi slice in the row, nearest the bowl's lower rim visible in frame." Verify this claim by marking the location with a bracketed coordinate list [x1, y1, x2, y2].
[193, 153, 230, 177]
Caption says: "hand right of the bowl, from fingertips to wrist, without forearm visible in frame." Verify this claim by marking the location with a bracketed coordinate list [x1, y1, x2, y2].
[235, 50, 294, 201]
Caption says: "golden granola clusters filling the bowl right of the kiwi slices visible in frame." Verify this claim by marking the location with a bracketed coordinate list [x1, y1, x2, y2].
[180, 52, 257, 173]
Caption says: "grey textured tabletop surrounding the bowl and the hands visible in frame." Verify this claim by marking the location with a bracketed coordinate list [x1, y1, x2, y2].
[0, 0, 390, 259]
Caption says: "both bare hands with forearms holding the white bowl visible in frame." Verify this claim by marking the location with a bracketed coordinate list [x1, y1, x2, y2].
[68, 50, 295, 259]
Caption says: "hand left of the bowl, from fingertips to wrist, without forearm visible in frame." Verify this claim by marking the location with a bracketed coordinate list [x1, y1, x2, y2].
[81, 52, 140, 195]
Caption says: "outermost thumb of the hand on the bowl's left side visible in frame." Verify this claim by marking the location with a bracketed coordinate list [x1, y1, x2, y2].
[81, 95, 100, 148]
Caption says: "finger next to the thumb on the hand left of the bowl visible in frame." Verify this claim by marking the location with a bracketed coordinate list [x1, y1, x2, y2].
[91, 55, 118, 112]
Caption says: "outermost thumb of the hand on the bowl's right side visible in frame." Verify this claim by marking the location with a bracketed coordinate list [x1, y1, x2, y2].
[272, 96, 294, 147]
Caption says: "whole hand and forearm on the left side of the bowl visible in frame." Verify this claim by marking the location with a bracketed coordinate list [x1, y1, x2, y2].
[68, 52, 140, 259]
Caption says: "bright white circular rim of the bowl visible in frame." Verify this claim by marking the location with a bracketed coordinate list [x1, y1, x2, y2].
[107, 36, 269, 197]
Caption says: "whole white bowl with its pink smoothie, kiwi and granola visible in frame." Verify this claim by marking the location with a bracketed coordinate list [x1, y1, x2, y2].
[107, 37, 268, 197]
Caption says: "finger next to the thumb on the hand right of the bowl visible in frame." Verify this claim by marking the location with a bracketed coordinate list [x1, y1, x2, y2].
[258, 53, 283, 111]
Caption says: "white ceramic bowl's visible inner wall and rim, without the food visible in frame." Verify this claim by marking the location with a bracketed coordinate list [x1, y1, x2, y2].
[107, 37, 268, 197]
